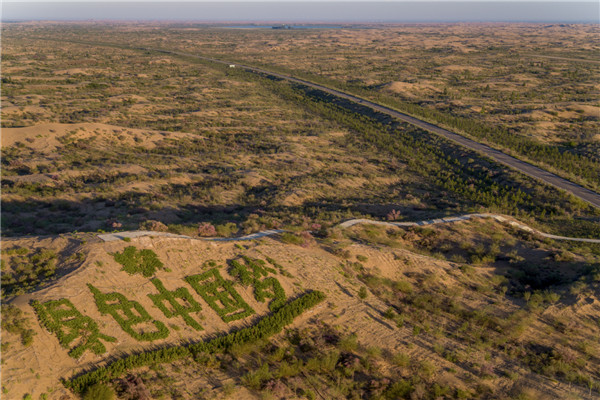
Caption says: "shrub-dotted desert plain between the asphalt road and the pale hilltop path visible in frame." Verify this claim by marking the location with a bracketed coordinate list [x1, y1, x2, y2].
[2, 25, 600, 241]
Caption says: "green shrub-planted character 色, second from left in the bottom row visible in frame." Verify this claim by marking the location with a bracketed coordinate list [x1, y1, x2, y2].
[87, 284, 169, 341]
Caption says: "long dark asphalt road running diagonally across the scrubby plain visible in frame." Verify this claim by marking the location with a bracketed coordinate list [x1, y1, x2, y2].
[146, 48, 600, 208]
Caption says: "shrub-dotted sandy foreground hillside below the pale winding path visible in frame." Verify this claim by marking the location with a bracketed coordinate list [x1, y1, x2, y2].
[2, 217, 600, 399]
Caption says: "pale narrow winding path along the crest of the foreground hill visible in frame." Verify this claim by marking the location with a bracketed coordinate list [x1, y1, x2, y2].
[98, 214, 600, 243]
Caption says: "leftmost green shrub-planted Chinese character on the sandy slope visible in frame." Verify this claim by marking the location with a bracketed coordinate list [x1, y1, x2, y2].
[31, 299, 117, 358]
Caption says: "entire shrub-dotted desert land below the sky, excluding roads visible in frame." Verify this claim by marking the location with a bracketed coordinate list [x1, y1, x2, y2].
[1, 23, 600, 400]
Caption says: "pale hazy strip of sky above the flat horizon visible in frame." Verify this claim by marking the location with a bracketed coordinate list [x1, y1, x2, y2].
[2, 0, 600, 24]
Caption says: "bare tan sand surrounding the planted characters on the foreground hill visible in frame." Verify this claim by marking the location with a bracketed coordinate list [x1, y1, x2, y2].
[2, 237, 418, 399]
